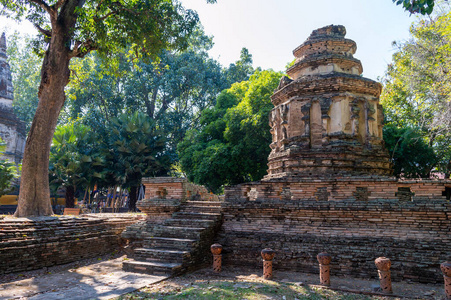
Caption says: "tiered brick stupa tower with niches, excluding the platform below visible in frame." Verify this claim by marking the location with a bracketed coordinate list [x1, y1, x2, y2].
[265, 25, 392, 180]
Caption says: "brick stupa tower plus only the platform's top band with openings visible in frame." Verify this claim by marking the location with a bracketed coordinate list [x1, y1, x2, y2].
[225, 25, 448, 201]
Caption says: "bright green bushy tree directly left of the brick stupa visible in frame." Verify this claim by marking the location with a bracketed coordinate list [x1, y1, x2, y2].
[178, 70, 282, 192]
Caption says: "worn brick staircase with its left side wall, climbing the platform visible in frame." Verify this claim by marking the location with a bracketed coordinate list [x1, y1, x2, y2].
[122, 177, 222, 275]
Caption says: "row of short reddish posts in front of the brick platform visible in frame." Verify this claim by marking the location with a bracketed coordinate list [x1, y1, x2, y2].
[211, 244, 451, 300]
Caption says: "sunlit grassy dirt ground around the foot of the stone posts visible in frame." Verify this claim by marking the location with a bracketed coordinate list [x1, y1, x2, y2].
[119, 266, 444, 300]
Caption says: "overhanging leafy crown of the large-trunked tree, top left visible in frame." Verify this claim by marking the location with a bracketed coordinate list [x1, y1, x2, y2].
[0, 0, 215, 57]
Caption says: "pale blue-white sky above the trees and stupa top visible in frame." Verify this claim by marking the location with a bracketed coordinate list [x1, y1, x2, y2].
[0, 0, 424, 79]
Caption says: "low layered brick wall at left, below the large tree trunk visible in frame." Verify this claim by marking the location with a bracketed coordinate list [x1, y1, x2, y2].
[0, 215, 141, 274]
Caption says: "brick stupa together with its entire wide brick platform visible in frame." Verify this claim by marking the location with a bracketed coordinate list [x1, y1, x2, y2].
[218, 25, 451, 282]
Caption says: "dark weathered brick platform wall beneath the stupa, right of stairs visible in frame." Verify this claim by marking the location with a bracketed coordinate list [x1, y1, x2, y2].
[219, 181, 451, 282]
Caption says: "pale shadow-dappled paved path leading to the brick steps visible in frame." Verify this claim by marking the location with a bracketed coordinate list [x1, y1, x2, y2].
[0, 256, 167, 300]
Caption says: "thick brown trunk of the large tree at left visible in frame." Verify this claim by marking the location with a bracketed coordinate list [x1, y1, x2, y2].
[14, 21, 70, 217]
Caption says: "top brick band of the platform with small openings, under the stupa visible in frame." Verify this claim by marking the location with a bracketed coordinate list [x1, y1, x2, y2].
[225, 177, 451, 201]
